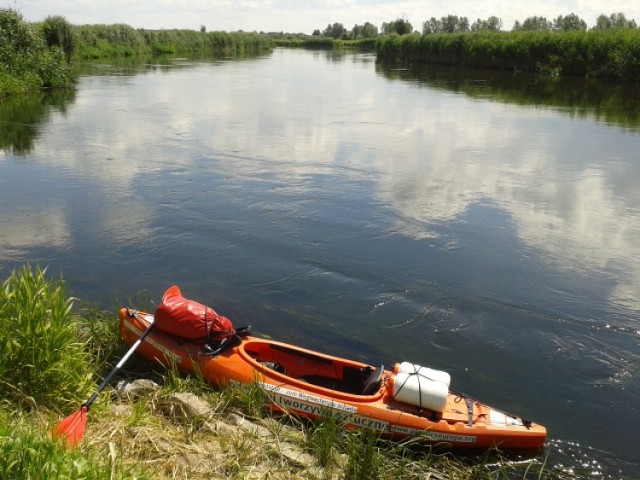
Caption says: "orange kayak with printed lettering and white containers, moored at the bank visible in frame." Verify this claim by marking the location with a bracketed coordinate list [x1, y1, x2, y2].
[120, 308, 547, 449]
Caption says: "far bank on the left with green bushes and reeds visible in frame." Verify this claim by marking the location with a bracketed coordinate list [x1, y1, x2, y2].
[0, 8, 273, 97]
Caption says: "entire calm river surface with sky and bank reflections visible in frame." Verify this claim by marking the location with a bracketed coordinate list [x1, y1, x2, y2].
[0, 49, 640, 478]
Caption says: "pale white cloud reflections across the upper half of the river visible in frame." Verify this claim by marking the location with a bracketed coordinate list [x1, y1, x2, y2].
[0, 51, 640, 316]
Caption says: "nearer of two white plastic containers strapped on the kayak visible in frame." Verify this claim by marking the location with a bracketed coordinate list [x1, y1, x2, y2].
[393, 372, 449, 412]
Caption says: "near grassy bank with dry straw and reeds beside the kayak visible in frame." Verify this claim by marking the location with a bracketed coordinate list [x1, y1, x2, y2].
[0, 267, 568, 480]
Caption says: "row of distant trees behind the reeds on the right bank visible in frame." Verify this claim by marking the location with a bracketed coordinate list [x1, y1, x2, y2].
[313, 12, 638, 40]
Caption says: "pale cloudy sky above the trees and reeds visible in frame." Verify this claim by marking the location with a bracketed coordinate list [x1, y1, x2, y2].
[6, 0, 640, 34]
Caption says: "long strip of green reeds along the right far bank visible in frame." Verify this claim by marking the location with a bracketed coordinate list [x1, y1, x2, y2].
[376, 29, 640, 82]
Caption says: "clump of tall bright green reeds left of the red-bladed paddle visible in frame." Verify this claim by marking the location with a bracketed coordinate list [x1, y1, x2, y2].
[0, 266, 92, 410]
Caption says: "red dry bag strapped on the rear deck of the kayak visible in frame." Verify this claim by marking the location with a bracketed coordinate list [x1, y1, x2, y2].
[154, 285, 236, 342]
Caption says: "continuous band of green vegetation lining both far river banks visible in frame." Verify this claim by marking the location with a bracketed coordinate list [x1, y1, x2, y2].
[0, 8, 640, 96]
